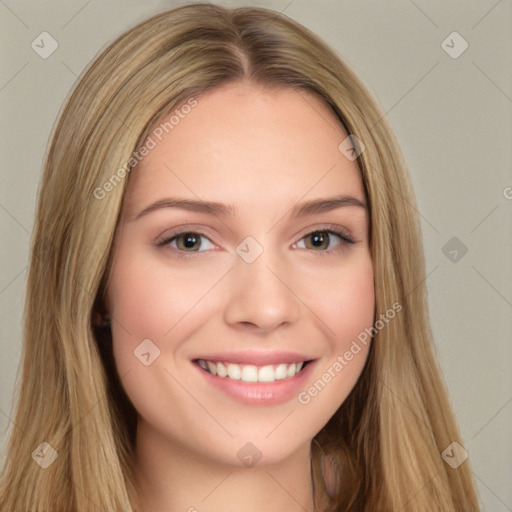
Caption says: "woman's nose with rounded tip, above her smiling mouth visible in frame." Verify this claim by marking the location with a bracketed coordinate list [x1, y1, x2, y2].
[224, 251, 300, 334]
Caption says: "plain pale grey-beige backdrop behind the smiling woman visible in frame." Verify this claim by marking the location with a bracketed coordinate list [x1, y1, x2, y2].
[0, 0, 512, 512]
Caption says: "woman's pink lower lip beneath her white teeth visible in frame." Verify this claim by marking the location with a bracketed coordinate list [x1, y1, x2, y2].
[193, 361, 315, 405]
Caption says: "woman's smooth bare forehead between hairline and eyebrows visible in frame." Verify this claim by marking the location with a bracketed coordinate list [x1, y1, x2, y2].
[125, 82, 364, 215]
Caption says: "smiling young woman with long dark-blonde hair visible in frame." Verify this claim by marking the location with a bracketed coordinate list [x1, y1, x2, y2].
[0, 5, 479, 512]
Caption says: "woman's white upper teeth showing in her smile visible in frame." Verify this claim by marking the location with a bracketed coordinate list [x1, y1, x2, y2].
[197, 359, 304, 382]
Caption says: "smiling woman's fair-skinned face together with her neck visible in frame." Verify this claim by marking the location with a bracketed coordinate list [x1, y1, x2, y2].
[107, 82, 374, 512]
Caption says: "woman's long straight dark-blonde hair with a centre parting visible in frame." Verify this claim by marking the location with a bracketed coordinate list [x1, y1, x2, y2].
[0, 4, 479, 512]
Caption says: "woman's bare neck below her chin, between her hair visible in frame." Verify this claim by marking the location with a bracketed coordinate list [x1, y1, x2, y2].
[135, 422, 322, 512]
